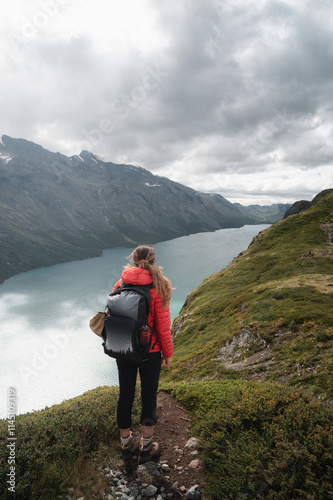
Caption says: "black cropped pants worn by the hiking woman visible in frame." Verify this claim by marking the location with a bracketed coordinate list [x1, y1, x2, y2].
[117, 352, 161, 429]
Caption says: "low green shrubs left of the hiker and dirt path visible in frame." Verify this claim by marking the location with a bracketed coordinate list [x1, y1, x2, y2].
[0, 387, 139, 500]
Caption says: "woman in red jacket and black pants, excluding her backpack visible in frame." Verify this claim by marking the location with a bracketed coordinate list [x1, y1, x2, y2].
[113, 245, 173, 463]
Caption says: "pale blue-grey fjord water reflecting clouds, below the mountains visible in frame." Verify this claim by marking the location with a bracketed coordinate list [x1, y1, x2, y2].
[0, 225, 268, 418]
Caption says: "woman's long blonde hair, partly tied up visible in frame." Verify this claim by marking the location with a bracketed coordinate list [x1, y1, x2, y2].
[126, 245, 172, 306]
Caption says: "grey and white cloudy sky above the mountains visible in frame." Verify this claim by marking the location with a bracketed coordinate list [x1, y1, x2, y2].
[0, 0, 333, 205]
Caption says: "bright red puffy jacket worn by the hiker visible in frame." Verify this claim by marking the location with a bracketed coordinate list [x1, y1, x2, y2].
[113, 267, 173, 358]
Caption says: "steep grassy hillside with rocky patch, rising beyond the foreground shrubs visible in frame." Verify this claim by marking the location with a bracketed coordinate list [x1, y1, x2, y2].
[169, 193, 333, 398]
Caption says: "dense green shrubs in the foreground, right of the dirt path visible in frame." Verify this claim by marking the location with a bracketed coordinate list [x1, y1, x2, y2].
[165, 381, 333, 500]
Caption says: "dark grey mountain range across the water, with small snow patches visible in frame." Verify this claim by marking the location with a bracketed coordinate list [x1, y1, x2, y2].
[0, 135, 291, 281]
